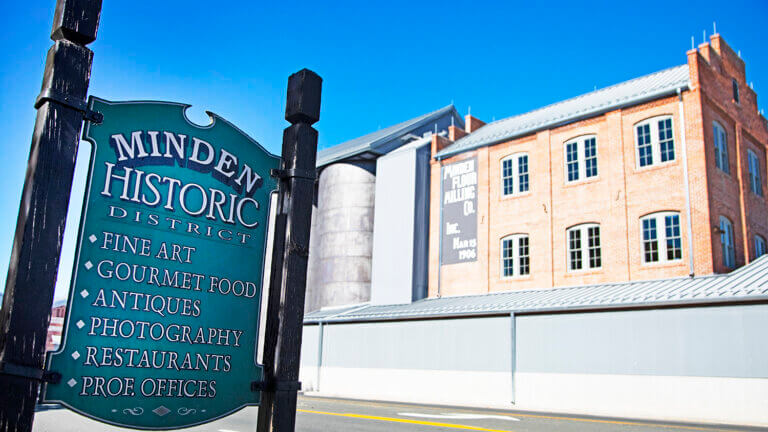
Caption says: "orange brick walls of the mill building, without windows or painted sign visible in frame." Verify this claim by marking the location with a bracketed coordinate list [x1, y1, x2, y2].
[429, 35, 768, 297]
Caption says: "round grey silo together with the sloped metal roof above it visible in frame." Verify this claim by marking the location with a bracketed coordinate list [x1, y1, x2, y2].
[305, 105, 463, 311]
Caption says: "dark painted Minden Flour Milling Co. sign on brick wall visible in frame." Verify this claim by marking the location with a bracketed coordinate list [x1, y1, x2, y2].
[440, 157, 477, 264]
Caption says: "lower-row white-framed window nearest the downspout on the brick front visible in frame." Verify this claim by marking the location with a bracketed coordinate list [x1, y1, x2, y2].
[640, 212, 683, 264]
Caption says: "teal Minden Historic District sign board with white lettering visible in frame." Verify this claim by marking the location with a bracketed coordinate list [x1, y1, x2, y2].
[43, 98, 279, 429]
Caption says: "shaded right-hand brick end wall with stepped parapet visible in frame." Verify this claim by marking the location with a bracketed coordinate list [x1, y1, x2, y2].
[688, 35, 768, 272]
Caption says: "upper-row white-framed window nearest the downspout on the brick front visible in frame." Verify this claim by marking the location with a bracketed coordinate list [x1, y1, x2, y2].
[635, 115, 675, 168]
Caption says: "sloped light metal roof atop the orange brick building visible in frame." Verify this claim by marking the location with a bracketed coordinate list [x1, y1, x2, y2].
[435, 64, 690, 159]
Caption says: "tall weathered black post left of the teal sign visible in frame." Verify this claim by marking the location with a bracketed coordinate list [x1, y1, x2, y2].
[0, 0, 101, 432]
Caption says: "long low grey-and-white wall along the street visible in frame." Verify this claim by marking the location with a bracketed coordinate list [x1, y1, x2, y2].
[300, 304, 768, 426]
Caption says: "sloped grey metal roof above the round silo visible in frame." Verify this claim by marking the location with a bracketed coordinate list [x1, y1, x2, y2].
[317, 104, 464, 167]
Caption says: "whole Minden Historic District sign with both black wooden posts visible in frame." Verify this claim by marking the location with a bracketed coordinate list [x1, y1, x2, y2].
[0, 0, 322, 432]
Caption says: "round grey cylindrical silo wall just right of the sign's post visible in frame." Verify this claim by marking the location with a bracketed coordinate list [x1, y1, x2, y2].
[305, 161, 376, 311]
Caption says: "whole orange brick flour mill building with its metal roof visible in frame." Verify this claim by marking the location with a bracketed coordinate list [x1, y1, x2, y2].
[429, 35, 768, 297]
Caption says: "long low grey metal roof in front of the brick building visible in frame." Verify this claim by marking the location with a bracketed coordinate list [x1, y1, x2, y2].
[304, 255, 768, 323]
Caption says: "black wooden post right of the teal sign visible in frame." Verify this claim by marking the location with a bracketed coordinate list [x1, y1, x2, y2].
[257, 69, 322, 432]
